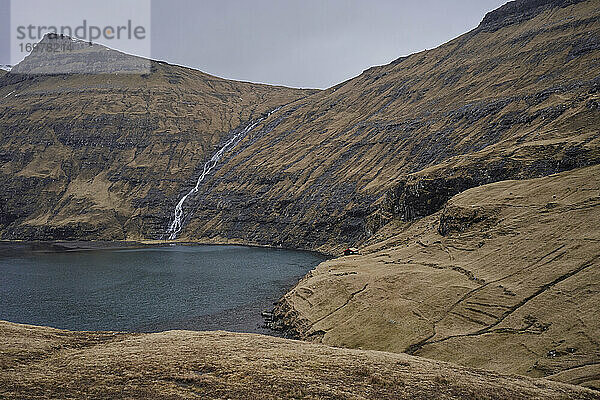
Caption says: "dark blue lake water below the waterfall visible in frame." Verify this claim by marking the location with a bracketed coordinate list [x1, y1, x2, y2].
[0, 246, 324, 333]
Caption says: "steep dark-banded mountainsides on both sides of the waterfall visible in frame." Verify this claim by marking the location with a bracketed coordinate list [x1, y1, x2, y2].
[0, 0, 600, 247]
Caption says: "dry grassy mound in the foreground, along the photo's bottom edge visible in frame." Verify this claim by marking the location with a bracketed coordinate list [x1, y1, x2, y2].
[0, 322, 597, 400]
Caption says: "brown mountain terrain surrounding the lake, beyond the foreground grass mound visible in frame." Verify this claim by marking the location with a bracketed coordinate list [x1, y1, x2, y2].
[0, 0, 600, 394]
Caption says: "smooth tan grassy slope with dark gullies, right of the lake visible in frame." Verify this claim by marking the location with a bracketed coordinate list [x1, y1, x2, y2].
[276, 166, 600, 389]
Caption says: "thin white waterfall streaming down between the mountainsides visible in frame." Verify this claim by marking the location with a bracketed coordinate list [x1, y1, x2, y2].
[167, 107, 281, 240]
